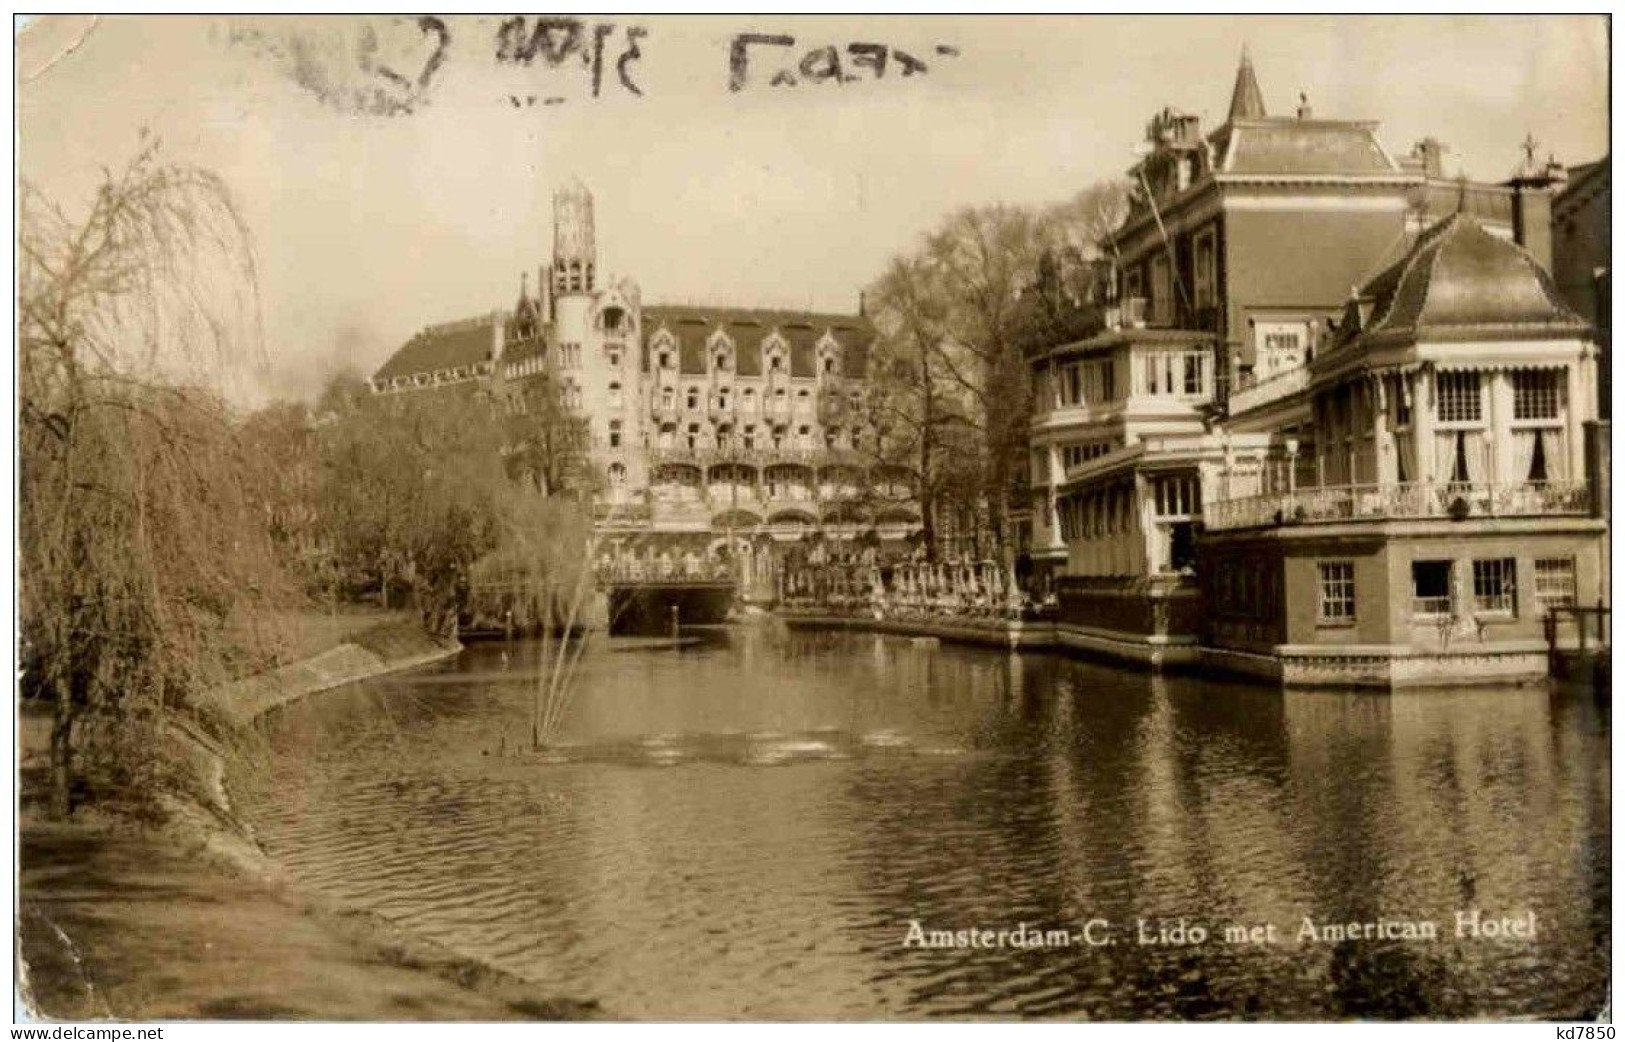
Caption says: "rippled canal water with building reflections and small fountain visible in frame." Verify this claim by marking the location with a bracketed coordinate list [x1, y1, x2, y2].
[250, 621, 1610, 1019]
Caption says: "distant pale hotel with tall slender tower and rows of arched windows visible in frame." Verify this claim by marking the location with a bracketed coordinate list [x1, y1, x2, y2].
[372, 182, 920, 592]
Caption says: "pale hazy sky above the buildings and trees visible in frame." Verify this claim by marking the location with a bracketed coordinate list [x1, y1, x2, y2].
[18, 15, 1609, 406]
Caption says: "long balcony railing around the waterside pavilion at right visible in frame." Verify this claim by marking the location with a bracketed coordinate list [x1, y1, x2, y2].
[1203, 481, 1591, 532]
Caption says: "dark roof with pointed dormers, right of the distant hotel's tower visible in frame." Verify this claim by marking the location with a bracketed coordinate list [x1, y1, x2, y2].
[644, 304, 874, 377]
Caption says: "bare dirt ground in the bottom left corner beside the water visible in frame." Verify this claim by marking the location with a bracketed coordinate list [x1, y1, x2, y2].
[20, 821, 596, 1021]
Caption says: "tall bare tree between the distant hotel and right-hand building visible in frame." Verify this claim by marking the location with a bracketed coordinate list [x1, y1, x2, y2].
[871, 182, 1128, 556]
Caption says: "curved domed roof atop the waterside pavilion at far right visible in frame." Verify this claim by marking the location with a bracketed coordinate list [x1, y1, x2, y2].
[1334, 213, 1591, 346]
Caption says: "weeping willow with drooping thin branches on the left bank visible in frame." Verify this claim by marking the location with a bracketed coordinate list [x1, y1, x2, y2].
[18, 133, 294, 816]
